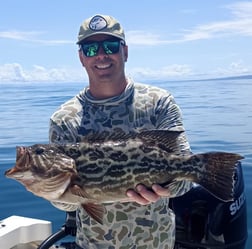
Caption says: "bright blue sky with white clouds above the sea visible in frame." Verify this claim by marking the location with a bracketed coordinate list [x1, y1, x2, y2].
[0, 0, 252, 83]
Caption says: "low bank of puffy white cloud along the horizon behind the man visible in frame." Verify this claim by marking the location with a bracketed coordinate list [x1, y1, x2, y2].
[0, 61, 252, 84]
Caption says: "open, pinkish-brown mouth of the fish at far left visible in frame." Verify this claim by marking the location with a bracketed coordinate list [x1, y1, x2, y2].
[5, 146, 30, 179]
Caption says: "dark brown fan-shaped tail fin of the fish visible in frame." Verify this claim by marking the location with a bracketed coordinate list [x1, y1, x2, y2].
[193, 152, 243, 201]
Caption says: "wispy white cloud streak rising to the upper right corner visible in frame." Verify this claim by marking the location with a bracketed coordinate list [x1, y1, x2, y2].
[127, 2, 252, 45]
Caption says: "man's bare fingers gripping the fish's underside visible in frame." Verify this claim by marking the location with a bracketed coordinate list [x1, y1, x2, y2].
[126, 184, 169, 205]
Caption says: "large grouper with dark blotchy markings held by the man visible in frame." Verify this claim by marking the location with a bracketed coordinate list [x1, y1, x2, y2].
[5, 130, 243, 223]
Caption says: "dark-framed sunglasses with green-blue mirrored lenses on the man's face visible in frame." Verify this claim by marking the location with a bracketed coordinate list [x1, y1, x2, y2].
[80, 39, 125, 57]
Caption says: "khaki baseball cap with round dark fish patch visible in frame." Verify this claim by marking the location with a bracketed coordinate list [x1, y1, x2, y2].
[77, 15, 125, 44]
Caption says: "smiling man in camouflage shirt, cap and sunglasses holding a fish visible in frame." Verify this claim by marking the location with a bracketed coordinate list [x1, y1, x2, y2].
[50, 15, 191, 249]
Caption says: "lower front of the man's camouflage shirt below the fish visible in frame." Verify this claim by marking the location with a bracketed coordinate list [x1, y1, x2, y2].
[76, 198, 175, 249]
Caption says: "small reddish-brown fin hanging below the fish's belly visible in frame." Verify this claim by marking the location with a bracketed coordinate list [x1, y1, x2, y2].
[81, 202, 106, 224]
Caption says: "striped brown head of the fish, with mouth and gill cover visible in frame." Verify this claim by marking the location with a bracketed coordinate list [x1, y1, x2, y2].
[5, 144, 77, 200]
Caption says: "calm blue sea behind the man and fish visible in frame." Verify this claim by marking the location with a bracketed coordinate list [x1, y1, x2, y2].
[0, 78, 252, 249]
